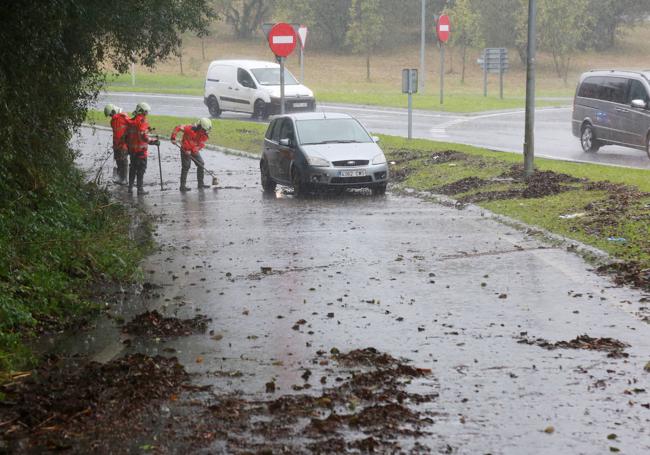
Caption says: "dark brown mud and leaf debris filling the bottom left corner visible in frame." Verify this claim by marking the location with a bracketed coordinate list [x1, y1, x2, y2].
[0, 354, 188, 453]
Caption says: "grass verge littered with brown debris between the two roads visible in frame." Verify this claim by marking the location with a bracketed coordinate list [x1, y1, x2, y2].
[88, 112, 650, 289]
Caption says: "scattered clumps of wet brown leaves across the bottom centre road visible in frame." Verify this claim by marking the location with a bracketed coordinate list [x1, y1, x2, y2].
[190, 348, 438, 454]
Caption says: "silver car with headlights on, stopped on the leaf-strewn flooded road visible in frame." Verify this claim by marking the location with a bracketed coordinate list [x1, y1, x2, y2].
[260, 112, 388, 195]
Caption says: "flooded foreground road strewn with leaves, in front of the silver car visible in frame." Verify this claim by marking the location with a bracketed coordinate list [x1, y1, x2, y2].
[67, 129, 650, 454]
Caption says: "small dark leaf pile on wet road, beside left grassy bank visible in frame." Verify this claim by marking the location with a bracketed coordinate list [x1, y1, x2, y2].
[122, 310, 211, 337]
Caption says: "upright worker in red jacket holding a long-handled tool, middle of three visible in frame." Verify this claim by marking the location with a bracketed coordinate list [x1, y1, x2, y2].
[126, 103, 160, 195]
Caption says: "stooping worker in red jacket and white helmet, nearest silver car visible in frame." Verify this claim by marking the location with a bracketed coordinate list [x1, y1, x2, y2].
[171, 118, 212, 192]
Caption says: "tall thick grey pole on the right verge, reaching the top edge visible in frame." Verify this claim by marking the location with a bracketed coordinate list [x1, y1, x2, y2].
[524, 0, 537, 177]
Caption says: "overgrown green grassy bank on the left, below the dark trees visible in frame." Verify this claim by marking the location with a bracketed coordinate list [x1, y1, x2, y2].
[0, 169, 152, 376]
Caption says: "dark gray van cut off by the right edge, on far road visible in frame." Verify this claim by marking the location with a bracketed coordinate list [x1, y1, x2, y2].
[572, 70, 650, 158]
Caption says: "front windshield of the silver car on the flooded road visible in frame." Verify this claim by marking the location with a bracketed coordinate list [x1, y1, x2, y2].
[296, 118, 372, 145]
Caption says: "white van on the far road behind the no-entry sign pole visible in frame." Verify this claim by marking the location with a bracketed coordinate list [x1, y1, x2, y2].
[203, 60, 316, 119]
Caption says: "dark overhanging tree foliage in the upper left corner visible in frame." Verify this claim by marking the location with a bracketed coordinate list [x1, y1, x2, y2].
[0, 0, 211, 203]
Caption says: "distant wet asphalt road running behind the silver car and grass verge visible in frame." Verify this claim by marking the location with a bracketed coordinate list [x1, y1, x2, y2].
[97, 92, 650, 169]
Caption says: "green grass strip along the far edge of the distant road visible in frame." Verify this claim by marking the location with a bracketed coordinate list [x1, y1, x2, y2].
[105, 74, 573, 113]
